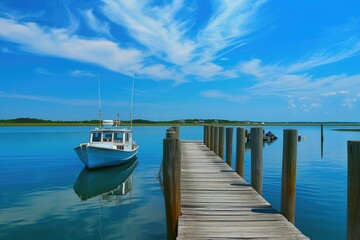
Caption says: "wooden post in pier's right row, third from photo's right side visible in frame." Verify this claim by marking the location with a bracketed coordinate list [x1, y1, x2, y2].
[250, 127, 263, 195]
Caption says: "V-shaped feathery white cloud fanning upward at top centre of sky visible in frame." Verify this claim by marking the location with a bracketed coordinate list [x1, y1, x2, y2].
[99, 0, 265, 79]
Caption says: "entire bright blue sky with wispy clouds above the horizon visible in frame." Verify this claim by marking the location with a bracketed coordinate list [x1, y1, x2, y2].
[0, 0, 360, 121]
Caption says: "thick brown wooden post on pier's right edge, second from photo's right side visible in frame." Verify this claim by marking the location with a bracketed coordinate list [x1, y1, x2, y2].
[281, 129, 298, 223]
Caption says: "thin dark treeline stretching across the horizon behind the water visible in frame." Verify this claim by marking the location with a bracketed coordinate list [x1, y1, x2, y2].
[0, 118, 360, 125]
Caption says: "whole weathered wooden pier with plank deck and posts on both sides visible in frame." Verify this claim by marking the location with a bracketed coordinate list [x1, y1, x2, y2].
[159, 125, 360, 240]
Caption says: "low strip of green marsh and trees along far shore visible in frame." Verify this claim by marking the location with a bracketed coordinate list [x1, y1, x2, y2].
[0, 118, 360, 126]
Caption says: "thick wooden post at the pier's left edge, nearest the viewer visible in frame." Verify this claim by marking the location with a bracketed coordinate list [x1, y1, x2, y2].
[163, 128, 181, 239]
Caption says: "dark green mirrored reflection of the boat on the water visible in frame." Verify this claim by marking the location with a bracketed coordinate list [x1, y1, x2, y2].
[74, 157, 138, 202]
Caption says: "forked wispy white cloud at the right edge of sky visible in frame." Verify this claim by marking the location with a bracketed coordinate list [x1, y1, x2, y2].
[239, 38, 360, 100]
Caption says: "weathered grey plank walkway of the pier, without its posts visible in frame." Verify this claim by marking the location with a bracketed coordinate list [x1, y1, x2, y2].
[177, 141, 309, 240]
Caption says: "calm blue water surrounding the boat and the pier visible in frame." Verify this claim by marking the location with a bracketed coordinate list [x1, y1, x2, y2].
[0, 127, 360, 239]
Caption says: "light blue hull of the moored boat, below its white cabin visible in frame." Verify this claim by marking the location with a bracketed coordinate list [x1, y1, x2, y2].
[74, 144, 138, 169]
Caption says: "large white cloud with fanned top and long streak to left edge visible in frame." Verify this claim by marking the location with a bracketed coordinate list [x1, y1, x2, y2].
[0, 0, 266, 83]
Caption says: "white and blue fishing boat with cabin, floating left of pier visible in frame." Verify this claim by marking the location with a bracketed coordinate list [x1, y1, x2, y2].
[74, 120, 139, 169]
